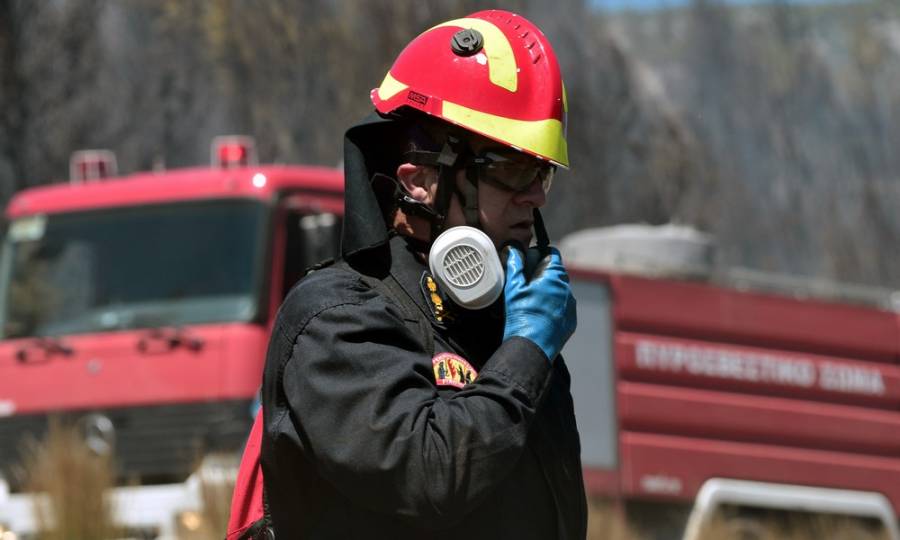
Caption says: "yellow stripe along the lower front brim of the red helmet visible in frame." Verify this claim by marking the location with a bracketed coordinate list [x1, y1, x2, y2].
[441, 101, 569, 168]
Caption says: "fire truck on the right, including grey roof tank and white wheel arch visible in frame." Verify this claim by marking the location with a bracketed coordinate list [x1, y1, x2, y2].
[563, 226, 900, 539]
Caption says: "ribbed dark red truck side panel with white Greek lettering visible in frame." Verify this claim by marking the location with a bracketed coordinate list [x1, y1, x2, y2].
[572, 269, 900, 511]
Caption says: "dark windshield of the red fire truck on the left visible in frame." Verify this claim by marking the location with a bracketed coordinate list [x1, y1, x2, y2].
[0, 200, 267, 339]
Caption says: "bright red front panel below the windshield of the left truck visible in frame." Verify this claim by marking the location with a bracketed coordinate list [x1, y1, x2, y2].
[0, 323, 268, 414]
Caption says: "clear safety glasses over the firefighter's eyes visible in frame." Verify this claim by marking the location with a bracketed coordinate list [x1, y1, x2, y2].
[470, 150, 556, 193]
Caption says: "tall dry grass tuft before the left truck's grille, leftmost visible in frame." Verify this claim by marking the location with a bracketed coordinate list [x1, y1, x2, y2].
[24, 418, 115, 540]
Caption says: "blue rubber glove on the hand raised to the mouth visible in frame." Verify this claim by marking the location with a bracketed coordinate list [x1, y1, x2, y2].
[503, 248, 578, 362]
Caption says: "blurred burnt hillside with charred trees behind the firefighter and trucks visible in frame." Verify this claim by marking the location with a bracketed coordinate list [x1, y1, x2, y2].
[0, 0, 900, 287]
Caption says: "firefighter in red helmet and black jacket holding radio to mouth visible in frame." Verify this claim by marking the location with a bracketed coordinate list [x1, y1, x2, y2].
[262, 10, 586, 540]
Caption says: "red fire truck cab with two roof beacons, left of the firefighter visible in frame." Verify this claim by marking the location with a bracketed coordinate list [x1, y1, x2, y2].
[0, 137, 343, 539]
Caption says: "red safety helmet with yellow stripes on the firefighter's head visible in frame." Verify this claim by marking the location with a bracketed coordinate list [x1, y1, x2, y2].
[371, 10, 569, 167]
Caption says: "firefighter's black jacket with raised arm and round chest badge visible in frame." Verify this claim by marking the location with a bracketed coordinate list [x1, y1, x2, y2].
[262, 237, 586, 540]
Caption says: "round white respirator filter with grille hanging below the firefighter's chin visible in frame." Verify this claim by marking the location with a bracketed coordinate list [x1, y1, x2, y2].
[428, 226, 504, 309]
